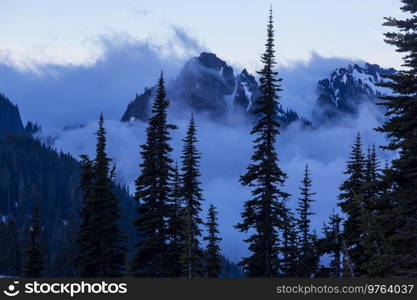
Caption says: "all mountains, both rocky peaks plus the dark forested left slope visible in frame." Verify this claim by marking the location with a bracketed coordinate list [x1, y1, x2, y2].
[0, 53, 396, 275]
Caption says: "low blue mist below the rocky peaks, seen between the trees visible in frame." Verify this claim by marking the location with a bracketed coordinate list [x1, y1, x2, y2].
[47, 102, 390, 261]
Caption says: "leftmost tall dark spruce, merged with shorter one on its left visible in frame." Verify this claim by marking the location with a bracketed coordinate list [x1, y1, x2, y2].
[76, 114, 126, 277]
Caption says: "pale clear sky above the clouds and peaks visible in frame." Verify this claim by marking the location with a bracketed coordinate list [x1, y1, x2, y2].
[0, 0, 401, 70]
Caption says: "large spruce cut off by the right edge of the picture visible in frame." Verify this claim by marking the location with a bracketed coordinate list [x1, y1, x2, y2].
[378, 0, 417, 277]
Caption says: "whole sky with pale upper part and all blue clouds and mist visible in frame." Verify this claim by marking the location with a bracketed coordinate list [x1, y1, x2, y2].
[0, 0, 401, 260]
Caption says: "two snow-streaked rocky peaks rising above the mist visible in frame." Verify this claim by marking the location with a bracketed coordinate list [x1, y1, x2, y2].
[122, 52, 396, 127]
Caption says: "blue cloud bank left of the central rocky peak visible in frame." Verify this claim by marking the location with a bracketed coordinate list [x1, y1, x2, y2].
[0, 27, 202, 128]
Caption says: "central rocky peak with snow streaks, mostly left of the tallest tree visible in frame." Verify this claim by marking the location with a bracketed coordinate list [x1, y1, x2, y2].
[122, 52, 307, 125]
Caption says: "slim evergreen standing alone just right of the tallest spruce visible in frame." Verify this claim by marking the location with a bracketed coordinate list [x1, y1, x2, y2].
[297, 165, 315, 278]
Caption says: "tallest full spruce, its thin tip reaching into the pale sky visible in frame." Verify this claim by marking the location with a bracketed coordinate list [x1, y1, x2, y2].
[236, 9, 288, 277]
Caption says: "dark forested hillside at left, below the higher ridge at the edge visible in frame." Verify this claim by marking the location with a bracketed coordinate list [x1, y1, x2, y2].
[0, 135, 136, 275]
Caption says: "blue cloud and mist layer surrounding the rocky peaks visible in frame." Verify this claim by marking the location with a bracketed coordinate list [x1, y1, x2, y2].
[0, 34, 390, 260]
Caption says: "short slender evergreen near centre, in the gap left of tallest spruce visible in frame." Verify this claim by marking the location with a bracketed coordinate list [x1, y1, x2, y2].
[204, 205, 221, 277]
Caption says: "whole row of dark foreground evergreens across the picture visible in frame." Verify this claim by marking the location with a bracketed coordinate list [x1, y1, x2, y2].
[0, 0, 417, 278]
